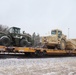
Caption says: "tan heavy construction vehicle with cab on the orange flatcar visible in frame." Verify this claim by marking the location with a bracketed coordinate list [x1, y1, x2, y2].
[41, 29, 66, 50]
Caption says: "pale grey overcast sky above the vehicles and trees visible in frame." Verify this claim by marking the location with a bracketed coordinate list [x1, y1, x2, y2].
[0, 0, 76, 38]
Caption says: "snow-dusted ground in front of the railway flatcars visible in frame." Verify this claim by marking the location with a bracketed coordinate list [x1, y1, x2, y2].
[0, 57, 76, 75]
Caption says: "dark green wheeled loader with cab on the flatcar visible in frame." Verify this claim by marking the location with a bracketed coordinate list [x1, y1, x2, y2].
[0, 27, 31, 47]
